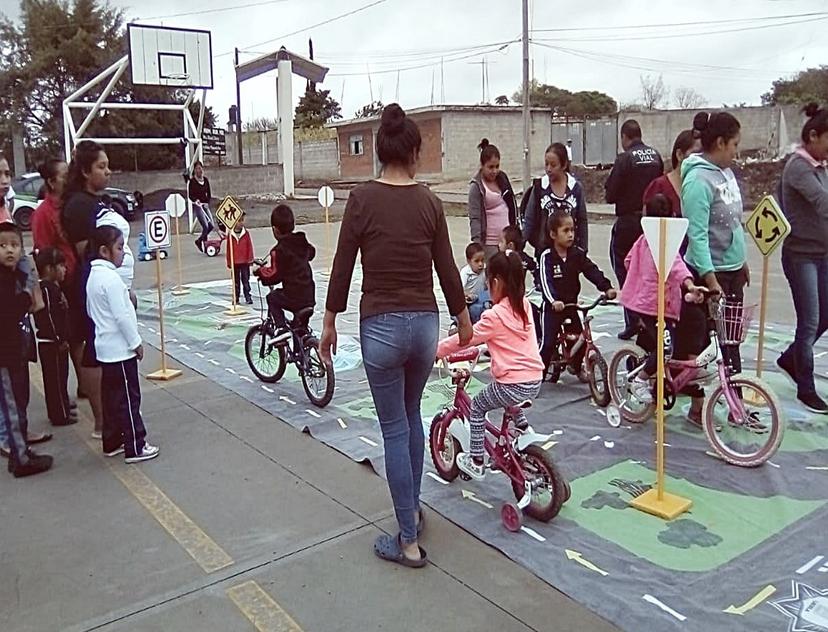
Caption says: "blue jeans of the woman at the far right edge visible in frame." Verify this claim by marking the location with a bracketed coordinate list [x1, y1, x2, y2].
[782, 250, 828, 396]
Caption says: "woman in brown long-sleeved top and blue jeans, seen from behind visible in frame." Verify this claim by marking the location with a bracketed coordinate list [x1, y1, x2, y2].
[320, 103, 472, 567]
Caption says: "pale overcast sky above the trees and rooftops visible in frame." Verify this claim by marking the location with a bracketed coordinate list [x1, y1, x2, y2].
[0, 0, 828, 126]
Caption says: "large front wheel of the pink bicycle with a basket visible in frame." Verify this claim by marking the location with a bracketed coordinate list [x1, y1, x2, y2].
[702, 375, 785, 467]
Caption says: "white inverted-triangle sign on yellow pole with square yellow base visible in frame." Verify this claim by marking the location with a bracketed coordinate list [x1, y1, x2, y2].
[630, 217, 693, 520]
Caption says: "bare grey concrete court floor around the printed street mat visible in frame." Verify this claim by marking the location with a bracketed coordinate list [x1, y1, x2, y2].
[0, 218, 792, 632]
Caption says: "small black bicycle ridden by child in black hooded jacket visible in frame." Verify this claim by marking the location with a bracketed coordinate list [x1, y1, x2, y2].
[244, 280, 336, 408]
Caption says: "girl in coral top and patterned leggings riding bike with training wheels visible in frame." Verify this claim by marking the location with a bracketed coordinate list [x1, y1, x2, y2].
[437, 251, 543, 480]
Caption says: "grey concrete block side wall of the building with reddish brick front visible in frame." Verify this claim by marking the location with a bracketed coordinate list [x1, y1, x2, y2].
[443, 110, 552, 181]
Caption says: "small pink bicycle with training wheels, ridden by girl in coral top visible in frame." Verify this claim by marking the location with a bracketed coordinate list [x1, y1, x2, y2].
[429, 347, 570, 531]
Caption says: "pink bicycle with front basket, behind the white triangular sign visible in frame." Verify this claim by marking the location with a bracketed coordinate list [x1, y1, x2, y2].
[607, 294, 784, 467]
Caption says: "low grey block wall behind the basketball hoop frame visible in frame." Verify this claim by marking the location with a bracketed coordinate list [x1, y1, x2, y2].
[110, 165, 284, 197]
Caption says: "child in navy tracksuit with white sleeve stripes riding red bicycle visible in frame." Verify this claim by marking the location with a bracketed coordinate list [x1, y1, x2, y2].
[540, 211, 616, 379]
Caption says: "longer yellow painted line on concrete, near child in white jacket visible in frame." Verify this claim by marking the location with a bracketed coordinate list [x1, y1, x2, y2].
[31, 371, 233, 573]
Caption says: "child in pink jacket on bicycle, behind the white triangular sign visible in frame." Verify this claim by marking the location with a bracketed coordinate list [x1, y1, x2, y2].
[621, 193, 703, 416]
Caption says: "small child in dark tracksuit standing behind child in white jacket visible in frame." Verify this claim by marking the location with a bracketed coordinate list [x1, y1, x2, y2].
[35, 248, 78, 426]
